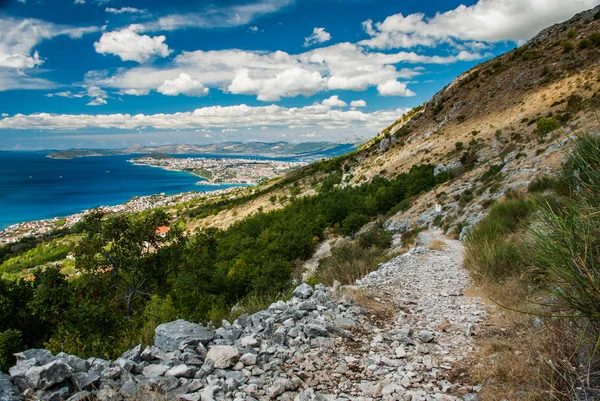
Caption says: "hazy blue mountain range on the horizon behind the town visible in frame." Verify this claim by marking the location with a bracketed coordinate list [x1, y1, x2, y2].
[48, 138, 364, 159]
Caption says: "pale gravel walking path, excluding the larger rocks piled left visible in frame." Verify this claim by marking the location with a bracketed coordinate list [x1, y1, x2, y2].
[300, 231, 486, 401]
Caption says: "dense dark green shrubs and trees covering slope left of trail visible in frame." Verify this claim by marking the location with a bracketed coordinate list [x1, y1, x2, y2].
[0, 158, 447, 363]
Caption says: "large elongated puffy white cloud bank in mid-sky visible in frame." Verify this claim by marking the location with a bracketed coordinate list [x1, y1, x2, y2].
[86, 43, 483, 101]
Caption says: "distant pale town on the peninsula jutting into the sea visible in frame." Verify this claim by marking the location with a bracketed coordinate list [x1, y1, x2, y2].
[129, 154, 307, 185]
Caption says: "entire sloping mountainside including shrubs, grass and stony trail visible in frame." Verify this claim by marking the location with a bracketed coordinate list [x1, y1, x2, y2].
[0, 6, 600, 401]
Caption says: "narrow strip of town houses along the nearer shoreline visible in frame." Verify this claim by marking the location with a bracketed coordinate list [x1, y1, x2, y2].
[0, 187, 241, 246]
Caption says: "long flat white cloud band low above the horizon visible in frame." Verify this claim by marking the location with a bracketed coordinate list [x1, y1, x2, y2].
[0, 104, 407, 132]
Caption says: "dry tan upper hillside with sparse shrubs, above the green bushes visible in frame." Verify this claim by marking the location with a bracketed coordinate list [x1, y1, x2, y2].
[185, 7, 600, 233]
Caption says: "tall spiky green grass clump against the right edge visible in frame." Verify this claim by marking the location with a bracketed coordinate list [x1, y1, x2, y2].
[532, 135, 600, 326]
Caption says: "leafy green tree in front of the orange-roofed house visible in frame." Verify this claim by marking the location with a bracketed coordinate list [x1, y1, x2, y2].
[75, 211, 185, 318]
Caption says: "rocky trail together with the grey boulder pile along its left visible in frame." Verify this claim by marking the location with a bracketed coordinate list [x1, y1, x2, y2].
[0, 231, 486, 401]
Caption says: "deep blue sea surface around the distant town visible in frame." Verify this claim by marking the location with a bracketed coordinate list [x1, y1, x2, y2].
[0, 148, 351, 229]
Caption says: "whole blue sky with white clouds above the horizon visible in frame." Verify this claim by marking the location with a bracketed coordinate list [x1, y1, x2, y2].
[0, 0, 600, 150]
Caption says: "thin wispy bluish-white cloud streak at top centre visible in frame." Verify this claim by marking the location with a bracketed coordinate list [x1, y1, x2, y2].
[139, 0, 295, 31]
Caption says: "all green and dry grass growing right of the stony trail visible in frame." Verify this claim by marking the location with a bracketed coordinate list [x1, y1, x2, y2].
[465, 135, 600, 399]
